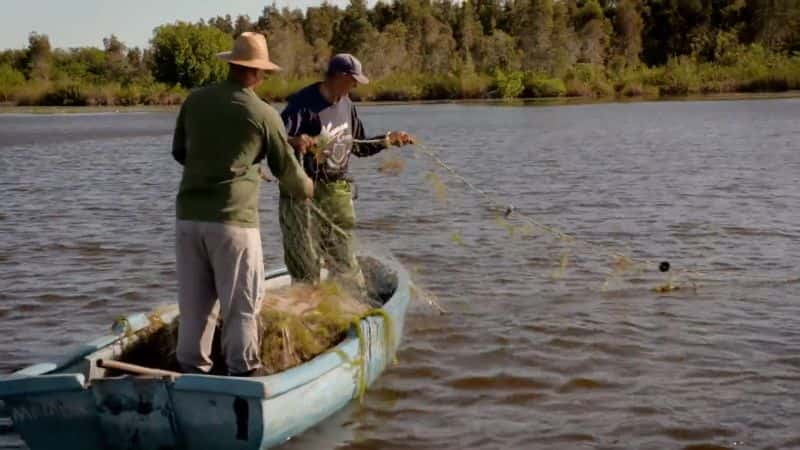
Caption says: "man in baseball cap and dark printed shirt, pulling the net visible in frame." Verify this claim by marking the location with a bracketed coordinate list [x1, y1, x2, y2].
[280, 53, 414, 287]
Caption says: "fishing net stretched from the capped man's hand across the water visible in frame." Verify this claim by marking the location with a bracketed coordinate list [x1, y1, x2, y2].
[404, 144, 797, 294]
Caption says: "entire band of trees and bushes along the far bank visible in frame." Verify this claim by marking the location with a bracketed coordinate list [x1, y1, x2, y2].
[0, 0, 800, 104]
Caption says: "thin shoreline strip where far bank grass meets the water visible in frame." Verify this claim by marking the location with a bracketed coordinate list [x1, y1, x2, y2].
[0, 90, 800, 115]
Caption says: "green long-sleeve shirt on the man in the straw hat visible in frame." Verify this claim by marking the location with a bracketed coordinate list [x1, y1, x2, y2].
[172, 80, 307, 227]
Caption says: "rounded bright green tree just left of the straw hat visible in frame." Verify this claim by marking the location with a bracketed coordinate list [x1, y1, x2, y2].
[150, 22, 232, 87]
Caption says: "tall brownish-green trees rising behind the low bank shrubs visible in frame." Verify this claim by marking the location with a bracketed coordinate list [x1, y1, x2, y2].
[202, 0, 800, 76]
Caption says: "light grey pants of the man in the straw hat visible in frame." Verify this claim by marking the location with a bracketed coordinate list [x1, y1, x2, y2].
[175, 220, 264, 374]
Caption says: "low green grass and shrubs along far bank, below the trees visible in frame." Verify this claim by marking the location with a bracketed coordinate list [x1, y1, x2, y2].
[0, 45, 800, 106]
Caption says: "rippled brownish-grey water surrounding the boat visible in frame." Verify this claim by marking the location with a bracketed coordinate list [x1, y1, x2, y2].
[0, 100, 800, 449]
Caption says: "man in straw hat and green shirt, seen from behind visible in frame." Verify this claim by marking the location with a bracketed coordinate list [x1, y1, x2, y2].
[172, 33, 313, 376]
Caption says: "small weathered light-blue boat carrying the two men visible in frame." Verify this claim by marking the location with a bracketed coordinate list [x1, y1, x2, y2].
[0, 259, 410, 450]
